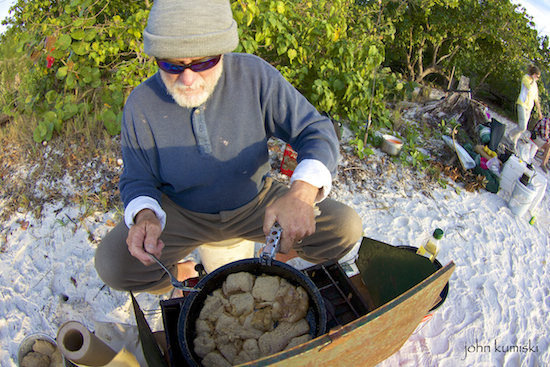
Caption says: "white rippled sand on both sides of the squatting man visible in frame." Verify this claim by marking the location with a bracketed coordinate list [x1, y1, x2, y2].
[0, 110, 550, 367]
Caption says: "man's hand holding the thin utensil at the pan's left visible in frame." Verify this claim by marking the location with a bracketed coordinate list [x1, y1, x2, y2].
[126, 209, 164, 266]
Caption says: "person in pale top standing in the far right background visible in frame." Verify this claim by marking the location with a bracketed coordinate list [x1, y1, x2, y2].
[510, 65, 542, 151]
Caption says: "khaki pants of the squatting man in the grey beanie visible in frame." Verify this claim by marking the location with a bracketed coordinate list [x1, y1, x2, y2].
[95, 177, 363, 294]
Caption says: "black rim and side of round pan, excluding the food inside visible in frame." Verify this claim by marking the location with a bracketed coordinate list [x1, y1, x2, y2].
[178, 258, 327, 366]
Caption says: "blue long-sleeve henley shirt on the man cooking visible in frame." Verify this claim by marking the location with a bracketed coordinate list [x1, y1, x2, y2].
[120, 53, 338, 217]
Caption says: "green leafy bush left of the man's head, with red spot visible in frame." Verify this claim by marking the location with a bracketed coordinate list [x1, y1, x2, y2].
[3, 0, 156, 142]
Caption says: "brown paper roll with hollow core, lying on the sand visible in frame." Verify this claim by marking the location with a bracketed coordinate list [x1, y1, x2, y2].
[57, 321, 116, 366]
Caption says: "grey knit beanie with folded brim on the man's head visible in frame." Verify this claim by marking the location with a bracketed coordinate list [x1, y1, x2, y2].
[143, 0, 239, 59]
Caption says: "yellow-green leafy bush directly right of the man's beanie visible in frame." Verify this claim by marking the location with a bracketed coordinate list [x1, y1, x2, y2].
[233, 0, 398, 134]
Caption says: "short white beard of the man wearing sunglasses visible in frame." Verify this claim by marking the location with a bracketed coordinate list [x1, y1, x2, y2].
[160, 59, 223, 108]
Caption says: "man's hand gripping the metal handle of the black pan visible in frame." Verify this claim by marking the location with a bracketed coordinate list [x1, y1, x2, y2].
[263, 180, 319, 254]
